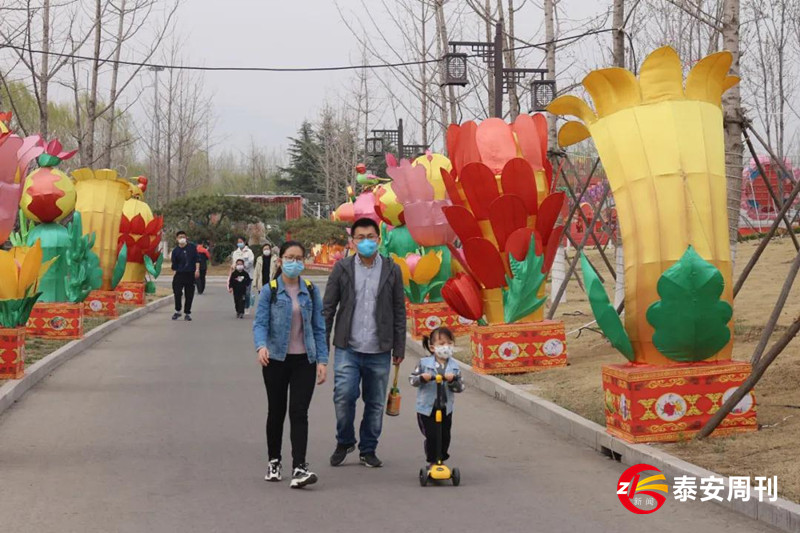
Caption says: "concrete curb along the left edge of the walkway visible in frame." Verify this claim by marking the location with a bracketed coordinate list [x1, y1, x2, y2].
[0, 296, 172, 414]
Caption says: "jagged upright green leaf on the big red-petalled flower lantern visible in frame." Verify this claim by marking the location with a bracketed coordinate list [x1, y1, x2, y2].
[503, 235, 547, 324]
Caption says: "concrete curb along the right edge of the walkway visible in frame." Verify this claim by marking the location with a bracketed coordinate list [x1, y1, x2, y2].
[407, 336, 800, 532]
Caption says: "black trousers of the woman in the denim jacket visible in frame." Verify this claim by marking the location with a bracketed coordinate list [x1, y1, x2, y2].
[262, 354, 317, 468]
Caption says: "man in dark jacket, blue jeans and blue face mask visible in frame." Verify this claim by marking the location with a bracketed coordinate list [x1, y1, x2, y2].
[323, 218, 406, 468]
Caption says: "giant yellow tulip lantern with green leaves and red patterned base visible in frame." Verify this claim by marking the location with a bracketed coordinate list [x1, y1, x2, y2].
[548, 47, 756, 441]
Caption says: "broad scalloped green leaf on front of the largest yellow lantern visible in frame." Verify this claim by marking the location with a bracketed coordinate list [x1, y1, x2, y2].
[646, 246, 733, 362]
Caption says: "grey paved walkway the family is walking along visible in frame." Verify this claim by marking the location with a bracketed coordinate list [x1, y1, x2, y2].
[0, 282, 772, 533]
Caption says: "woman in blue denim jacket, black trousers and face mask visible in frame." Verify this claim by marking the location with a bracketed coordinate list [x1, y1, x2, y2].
[253, 241, 328, 488]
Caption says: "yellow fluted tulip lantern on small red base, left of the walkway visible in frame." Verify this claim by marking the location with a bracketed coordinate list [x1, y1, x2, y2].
[72, 168, 132, 316]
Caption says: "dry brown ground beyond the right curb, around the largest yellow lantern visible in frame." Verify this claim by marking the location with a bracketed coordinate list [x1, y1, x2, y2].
[461, 238, 800, 501]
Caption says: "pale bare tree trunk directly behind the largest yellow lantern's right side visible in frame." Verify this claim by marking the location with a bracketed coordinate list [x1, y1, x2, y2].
[722, 0, 744, 263]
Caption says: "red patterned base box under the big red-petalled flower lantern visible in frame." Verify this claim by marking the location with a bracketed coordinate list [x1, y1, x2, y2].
[470, 320, 567, 374]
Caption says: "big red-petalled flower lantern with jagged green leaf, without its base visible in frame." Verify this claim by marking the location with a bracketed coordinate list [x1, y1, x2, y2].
[441, 115, 565, 324]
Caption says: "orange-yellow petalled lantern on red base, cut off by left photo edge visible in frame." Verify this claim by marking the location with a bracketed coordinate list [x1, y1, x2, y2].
[0, 241, 52, 379]
